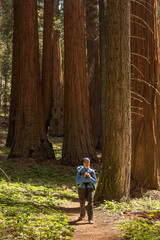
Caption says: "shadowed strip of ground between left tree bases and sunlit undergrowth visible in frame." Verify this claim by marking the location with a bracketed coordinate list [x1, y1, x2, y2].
[0, 158, 77, 188]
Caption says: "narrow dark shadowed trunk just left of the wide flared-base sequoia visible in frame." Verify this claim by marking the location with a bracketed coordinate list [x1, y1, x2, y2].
[6, 2, 21, 147]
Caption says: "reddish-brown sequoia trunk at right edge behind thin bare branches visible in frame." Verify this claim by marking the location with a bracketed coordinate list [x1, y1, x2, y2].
[131, 0, 160, 188]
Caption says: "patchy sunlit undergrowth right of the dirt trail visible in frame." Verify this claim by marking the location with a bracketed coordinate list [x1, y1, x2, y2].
[100, 196, 160, 240]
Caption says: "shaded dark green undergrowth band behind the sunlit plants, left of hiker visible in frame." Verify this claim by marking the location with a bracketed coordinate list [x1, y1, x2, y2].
[0, 160, 76, 189]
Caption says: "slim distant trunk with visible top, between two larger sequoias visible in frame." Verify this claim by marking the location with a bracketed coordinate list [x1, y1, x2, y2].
[49, 30, 64, 137]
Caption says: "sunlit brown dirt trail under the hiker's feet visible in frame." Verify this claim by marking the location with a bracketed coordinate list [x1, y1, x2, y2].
[61, 199, 122, 240]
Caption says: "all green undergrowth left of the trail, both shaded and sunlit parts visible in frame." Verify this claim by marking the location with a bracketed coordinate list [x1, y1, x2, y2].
[0, 143, 77, 240]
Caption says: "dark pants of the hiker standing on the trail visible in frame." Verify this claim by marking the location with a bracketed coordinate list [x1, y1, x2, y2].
[78, 188, 94, 220]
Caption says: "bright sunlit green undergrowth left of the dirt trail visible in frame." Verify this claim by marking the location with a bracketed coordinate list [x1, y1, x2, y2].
[0, 180, 74, 240]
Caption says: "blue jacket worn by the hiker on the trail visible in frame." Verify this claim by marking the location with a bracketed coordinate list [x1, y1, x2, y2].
[76, 166, 97, 189]
